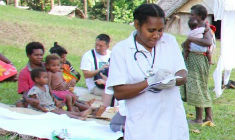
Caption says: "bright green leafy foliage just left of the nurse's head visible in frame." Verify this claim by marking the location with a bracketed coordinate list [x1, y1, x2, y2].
[112, 0, 145, 23]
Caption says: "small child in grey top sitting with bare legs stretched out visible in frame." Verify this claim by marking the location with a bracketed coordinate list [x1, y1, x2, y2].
[28, 68, 91, 119]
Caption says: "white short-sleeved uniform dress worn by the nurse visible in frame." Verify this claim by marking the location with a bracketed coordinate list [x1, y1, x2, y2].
[106, 32, 189, 140]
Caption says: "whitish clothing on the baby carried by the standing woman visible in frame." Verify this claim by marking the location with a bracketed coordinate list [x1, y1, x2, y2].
[188, 27, 208, 52]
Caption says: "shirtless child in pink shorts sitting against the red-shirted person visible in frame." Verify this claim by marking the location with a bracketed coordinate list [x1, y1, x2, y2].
[46, 54, 77, 111]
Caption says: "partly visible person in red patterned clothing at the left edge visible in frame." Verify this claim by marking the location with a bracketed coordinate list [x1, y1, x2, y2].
[0, 53, 17, 82]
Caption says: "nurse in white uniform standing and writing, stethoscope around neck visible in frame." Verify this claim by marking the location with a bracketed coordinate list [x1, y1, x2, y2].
[106, 4, 189, 140]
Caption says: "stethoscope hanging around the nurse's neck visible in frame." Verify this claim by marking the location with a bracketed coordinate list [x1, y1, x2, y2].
[134, 35, 156, 78]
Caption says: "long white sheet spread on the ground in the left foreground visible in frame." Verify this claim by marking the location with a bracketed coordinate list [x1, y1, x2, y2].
[0, 107, 122, 140]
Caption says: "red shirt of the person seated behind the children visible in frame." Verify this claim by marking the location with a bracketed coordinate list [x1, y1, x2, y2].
[18, 64, 34, 94]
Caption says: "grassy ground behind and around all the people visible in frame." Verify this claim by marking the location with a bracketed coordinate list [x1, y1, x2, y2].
[0, 6, 235, 140]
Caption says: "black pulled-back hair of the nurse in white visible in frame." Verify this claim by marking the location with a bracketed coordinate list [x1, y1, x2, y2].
[133, 3, 165, 25]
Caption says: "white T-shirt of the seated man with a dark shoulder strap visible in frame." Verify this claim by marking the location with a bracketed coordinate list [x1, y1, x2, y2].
[80, 49, 111, 92]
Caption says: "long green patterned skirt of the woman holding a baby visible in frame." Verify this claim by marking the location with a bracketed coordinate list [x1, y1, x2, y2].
[181, 53, 212, 107]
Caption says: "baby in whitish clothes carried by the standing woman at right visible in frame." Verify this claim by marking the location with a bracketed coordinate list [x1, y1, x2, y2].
[184, 18, 212, 64]
